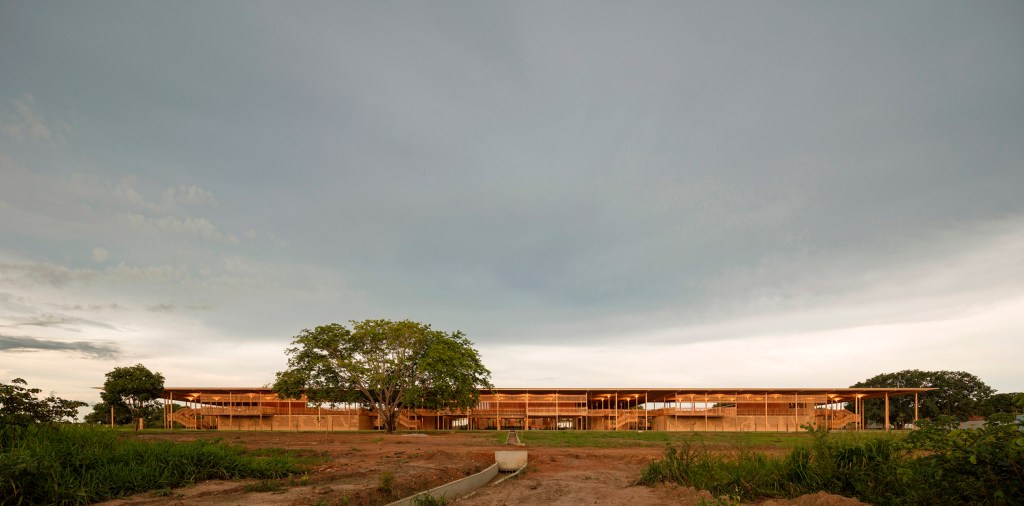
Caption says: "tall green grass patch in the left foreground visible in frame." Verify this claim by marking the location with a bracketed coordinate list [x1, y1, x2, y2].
[0, 425, 317, 504]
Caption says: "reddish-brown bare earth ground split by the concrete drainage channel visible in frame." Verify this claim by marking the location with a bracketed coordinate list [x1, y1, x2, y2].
[97, 432, 862, 506]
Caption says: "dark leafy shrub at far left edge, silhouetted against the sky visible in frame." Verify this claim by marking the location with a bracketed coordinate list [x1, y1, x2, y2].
[0, 378, 89, 427]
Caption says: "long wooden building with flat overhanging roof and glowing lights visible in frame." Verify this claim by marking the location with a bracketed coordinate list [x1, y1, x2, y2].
[157, 387, 932, 432]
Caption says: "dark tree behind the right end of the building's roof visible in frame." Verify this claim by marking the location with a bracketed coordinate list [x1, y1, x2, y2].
[852, 369, 995, 427]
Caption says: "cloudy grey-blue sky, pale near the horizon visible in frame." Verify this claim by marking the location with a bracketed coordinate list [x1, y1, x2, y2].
[0, 0, 1024, 403]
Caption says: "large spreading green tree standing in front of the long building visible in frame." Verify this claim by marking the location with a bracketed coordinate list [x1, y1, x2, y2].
[273, 320, 493, 433]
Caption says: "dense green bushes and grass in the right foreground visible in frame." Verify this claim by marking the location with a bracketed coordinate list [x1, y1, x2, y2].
[639, 415, 1024, 505]
